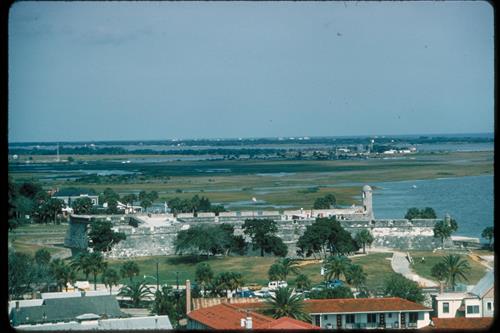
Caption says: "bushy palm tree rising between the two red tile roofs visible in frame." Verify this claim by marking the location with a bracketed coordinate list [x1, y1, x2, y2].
[266, 287, 311, 322]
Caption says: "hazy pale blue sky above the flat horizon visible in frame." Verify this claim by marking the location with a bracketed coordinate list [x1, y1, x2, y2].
[8, 1, 494, 141]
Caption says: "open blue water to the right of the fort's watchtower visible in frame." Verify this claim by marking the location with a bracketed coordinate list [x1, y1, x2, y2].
[370, 175, 494, 241]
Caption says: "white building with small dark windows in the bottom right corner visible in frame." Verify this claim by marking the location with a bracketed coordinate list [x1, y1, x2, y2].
[432, 271, 495, 318]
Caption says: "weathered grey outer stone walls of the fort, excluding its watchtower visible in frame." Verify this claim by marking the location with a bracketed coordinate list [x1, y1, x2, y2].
[65, 216, 441, 258]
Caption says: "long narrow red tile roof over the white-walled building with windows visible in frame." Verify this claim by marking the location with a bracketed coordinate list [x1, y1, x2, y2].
[304, 297, 432, 314]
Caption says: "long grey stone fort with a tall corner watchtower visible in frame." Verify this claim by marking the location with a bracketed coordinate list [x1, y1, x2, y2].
[64, 185, 441, 258]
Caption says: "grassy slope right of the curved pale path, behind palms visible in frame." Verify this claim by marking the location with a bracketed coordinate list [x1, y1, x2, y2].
[410, 251, 486, 285]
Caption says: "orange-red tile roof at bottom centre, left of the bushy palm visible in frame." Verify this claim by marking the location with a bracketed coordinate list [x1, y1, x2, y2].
[188, 303, 319, 330]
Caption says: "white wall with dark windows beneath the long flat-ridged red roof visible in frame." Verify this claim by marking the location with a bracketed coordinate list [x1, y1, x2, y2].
[311, 311, 430, 329]
